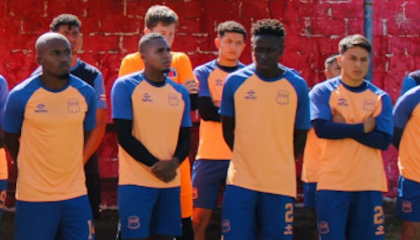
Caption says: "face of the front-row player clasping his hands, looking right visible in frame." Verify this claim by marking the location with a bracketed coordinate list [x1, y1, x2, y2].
[141, 38, 172, 73]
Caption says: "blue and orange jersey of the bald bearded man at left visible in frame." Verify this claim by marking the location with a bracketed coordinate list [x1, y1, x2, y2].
[4, 75, 96, 202]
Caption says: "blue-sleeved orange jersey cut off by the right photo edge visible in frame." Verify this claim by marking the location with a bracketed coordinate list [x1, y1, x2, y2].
[394, 86, 420, 182]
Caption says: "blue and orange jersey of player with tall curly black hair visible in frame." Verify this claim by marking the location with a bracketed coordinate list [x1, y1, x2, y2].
[220, 64, 311, 197]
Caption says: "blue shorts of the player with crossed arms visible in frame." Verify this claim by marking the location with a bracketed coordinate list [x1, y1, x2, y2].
[316, 190, 385, 240]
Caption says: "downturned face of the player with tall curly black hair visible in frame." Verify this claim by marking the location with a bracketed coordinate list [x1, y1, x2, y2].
[252, 35, 284, 71]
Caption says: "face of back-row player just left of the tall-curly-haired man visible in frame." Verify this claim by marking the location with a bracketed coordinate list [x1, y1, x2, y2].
[215, 32, 245, 61]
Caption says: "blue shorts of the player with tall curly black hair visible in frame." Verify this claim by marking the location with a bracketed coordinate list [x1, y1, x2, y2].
[222, 185, 295, 240]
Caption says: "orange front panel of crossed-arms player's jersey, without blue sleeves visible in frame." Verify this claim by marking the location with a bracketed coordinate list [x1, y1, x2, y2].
[318, 85, 387, 191]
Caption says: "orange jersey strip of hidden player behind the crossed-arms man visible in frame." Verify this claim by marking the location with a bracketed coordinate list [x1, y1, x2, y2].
[302, 128, 325, 183]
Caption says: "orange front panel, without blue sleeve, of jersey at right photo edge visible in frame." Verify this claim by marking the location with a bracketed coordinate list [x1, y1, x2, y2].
[398, 105, 420, 182]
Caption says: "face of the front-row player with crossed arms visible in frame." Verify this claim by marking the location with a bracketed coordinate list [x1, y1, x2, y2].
[337, 47, 370, 81]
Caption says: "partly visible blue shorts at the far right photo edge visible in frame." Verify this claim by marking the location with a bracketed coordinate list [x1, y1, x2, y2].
[396, 176, 420, 222]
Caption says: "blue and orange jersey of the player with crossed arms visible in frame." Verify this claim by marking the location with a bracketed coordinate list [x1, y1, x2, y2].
[310, 77, 394, 192]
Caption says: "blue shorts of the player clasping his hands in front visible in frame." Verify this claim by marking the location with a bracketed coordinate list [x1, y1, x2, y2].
[118, 185, 182, 239]
